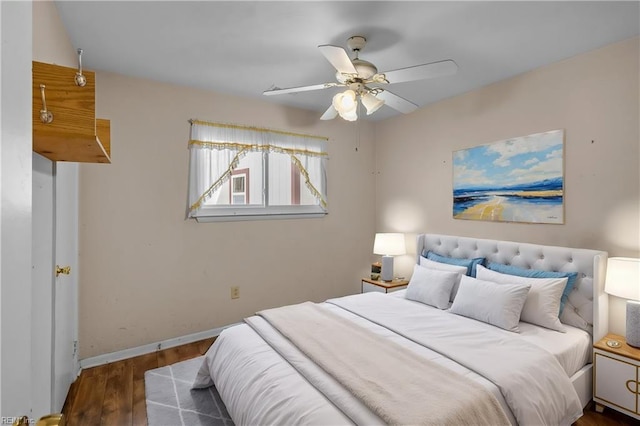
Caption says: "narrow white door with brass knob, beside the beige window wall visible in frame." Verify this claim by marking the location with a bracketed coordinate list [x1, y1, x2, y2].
[53, 162, 79, 412]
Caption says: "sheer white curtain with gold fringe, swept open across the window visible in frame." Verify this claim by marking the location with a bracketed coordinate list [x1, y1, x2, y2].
[188, 120, 327, 217]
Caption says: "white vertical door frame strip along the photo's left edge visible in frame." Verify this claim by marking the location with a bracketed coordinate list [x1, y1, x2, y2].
[0, 1, 33, 416]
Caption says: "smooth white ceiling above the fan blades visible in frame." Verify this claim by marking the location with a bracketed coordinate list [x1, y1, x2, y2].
[56, 1, 640, 120]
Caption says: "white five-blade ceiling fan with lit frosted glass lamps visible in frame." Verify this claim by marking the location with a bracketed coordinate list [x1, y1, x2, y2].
[263, 36, 458, 121]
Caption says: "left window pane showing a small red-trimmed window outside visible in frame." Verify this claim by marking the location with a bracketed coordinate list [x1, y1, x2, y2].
[205, 152, 264, 206]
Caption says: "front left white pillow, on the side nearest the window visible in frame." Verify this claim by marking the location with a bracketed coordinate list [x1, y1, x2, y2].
[405, 265, 459, 309]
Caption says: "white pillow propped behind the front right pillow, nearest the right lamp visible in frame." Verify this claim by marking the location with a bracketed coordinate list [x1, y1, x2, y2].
[476, 265, 568, 333]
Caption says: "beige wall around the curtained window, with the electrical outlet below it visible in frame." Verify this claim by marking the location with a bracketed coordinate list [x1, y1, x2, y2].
[79, 72, 374, 359]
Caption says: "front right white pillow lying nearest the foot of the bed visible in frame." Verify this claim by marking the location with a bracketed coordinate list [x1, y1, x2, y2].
[449, 275, 531, 332]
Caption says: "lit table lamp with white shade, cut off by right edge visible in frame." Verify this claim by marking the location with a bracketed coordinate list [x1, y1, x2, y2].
[604, 257, 640, 347]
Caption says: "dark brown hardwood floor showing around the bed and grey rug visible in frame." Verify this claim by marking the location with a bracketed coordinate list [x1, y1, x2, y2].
[62, 338, 640, 426]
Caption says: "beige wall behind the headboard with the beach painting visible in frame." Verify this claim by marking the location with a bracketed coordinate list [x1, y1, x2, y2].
[375, 38, 640, 332]
